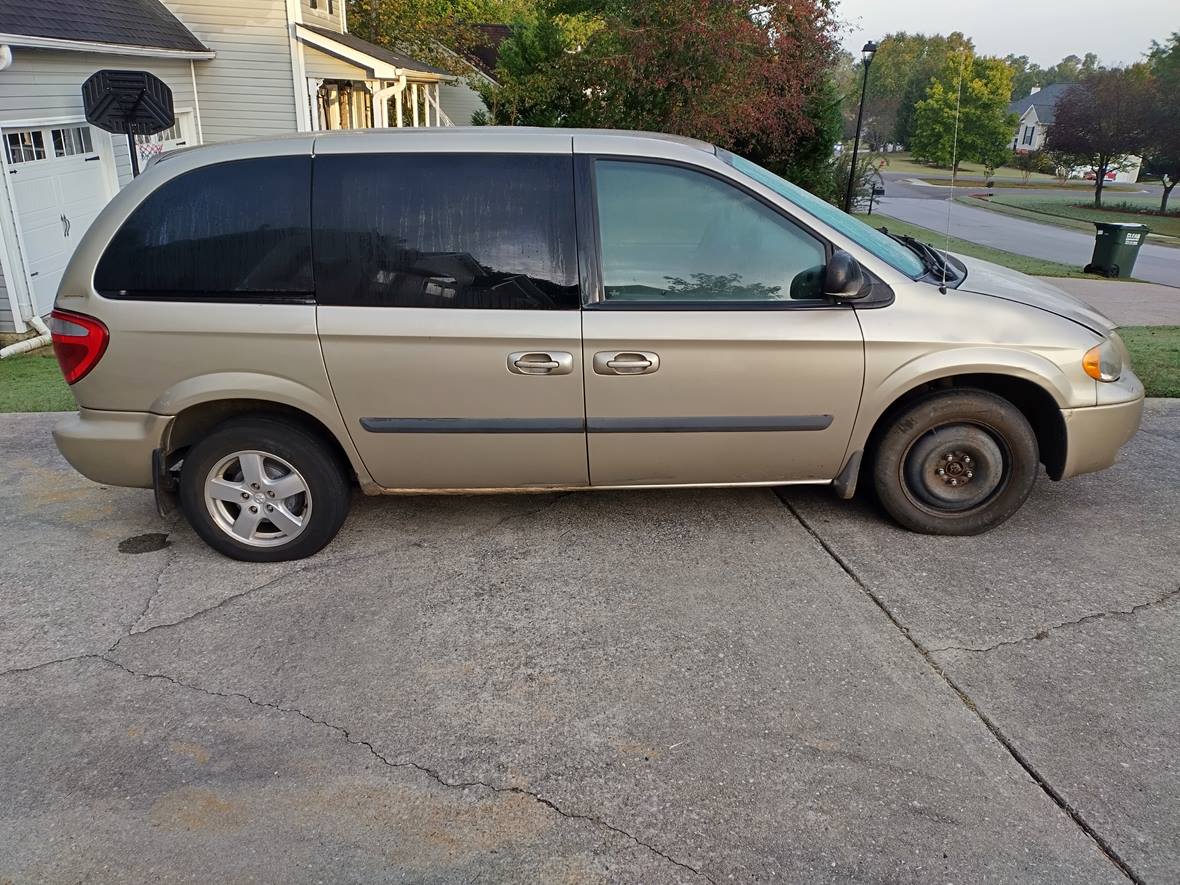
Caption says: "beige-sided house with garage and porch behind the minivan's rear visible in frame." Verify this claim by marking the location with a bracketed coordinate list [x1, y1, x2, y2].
[0, 0, 460, 332]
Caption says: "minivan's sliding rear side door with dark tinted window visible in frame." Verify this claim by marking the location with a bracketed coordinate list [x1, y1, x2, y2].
[313, 149, 588, 490]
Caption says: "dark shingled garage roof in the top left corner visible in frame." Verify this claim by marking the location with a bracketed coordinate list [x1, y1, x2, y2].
[0, 0, 209, 52]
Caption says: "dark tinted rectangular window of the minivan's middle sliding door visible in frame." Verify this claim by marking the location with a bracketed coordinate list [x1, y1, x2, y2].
[313, 153, 579, 310]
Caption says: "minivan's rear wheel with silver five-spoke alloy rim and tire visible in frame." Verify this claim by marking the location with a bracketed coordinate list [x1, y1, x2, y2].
[179, 418, 352, 563]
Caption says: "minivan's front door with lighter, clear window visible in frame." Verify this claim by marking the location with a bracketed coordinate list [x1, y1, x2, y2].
[583, 158, 864, 485]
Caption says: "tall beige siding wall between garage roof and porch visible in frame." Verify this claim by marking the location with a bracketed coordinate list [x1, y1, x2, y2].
[166, 0, 302, 143]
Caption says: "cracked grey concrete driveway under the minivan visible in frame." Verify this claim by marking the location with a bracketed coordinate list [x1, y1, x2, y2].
[0, 401, 1180, 883]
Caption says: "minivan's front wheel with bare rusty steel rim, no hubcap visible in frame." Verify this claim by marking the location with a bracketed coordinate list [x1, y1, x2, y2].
[873, 389, 1040, 535]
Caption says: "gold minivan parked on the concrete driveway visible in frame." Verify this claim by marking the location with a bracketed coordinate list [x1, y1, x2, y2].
[52, 129, 1143, 561]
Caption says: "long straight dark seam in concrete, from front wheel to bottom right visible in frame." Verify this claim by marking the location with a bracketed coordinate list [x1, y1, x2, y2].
[778, 494, 1145, 885]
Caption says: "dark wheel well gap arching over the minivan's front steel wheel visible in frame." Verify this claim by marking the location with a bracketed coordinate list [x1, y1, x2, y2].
[865, 374, 1067, 479]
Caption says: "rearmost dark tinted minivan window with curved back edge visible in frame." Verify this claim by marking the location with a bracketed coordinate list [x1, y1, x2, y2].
[94, 157, 314, 301]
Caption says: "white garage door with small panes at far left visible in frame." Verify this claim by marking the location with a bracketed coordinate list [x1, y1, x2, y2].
[4, 125, 110, 316]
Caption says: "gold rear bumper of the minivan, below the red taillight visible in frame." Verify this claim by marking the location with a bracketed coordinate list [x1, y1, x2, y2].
[53, 408, 172, 489]
